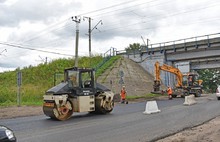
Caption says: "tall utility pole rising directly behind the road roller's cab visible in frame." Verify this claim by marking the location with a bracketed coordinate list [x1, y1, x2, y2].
[72, 16, 81, 67]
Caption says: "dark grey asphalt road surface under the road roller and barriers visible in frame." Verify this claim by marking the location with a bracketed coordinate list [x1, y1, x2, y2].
[0, 95, 220, 142]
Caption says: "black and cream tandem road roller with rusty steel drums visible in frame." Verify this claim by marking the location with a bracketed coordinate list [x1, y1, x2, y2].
[43, 67, 114, 121]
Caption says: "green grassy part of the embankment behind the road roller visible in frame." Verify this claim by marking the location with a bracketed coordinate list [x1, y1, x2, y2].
[0, 56, 120, 106]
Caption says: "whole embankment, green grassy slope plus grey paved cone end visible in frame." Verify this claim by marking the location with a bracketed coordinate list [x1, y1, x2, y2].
[0, 56, 153, 106]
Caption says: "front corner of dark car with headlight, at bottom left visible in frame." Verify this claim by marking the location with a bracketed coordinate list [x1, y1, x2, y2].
[0, 125, 16, 142]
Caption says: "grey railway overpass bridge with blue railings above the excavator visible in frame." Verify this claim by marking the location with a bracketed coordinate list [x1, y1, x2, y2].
[117, 33, 220, 85]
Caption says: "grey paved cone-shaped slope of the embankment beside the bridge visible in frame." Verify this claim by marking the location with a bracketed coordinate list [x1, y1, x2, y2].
[98, 57, 154, 96]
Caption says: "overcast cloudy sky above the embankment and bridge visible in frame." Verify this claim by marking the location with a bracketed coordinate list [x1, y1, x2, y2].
[0, 0, 220, 72]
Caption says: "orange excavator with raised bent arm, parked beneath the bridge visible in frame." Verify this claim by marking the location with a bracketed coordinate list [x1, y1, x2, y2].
[153, 61, 203, 97]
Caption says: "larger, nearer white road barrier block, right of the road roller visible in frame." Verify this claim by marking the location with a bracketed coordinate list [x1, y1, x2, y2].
[143, 101, 160, 114]
